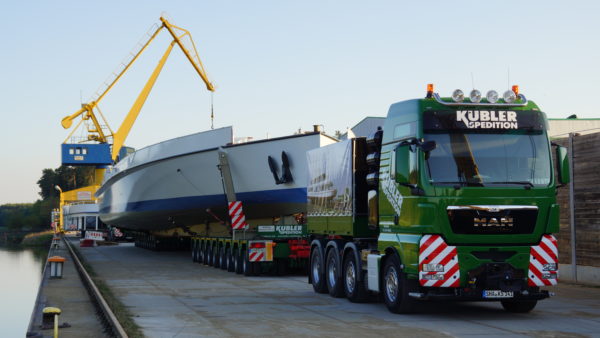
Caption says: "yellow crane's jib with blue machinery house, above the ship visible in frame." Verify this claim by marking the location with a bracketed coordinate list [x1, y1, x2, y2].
[61, 17, 215, 166]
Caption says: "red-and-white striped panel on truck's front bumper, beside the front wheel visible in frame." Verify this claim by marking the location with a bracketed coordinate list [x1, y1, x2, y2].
[419, 235, 460, 288]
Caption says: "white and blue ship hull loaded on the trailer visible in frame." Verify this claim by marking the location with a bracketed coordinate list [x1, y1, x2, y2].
[97, 128, 335, 231]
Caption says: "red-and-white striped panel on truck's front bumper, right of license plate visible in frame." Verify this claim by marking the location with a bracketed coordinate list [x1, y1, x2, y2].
[527, 235, 558, 286]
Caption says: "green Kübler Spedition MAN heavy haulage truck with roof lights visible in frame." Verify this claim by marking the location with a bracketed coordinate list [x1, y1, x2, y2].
[307, 85, 569, 313]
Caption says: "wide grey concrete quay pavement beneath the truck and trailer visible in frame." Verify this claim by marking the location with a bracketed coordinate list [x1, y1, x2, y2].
[79, 244, 600, 337]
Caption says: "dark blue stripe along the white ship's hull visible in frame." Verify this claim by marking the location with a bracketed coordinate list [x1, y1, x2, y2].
[100, 188, 306, 214]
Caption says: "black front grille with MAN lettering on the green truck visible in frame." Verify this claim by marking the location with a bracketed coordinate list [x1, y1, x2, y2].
[447, 205, 538, 235]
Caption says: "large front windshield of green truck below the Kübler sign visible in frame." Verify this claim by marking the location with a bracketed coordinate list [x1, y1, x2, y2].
[425, 132, 551, 187]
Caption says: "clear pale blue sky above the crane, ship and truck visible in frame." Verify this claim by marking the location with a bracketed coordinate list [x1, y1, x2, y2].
[0, 1, 600, 203]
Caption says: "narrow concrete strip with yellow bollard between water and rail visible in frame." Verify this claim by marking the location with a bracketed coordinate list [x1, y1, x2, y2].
[28, 241, 107, 338]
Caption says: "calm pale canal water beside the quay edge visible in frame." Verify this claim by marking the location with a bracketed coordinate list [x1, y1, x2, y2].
[0, 243, 48, 337]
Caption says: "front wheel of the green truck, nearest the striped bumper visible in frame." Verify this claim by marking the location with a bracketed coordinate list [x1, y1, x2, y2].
[383, 255, 415, 313]
